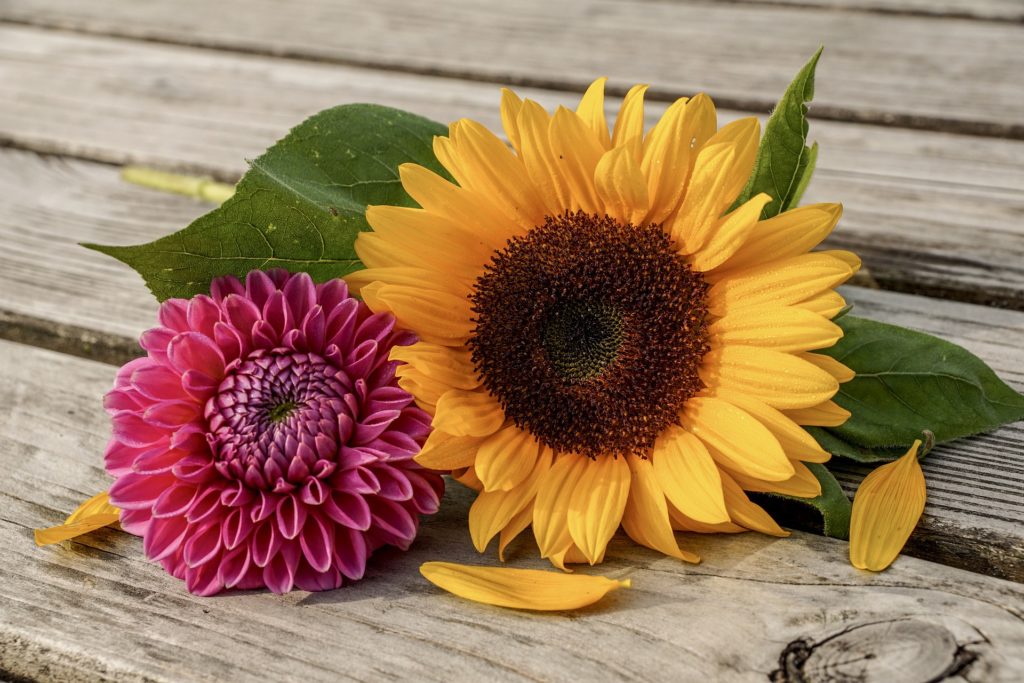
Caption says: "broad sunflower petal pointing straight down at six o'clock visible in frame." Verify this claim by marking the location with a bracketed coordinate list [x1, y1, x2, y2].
[567, 456, 630, 564]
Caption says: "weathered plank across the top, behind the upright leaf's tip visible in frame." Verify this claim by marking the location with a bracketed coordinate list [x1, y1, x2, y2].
[0, 0, 1024, 137]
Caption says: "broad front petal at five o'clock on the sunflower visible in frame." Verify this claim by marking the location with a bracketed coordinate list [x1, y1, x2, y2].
[651, 425, 729, 524]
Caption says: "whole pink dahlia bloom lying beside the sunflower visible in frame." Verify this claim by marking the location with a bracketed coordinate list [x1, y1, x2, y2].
[105, 270, 443, 595]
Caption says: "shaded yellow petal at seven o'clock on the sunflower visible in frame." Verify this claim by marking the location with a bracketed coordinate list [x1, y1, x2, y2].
[469, 449, 552, 553]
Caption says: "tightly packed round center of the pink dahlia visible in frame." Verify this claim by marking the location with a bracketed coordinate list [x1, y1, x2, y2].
[206, 350, 355, 492]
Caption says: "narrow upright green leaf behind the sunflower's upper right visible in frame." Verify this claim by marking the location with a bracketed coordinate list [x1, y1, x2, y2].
[733, 47, 824, 218]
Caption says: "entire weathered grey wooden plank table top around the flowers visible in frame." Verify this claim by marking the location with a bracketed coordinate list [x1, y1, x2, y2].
[0, 0, 1024, 681]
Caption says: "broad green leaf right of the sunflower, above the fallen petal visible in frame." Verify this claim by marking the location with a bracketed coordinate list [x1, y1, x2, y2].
[812, 315, 1024, 462]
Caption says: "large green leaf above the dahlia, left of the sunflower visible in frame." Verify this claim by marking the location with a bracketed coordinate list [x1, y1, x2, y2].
[85, 104, 446, 301]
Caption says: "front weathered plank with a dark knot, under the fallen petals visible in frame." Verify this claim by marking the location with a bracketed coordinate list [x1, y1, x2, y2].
[0, 342, 1024, 681]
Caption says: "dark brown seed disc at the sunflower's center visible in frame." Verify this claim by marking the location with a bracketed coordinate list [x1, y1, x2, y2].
[469, 212, 708, 458]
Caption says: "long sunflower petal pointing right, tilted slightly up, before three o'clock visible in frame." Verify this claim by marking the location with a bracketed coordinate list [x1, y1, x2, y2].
[708, 253, 853, 316]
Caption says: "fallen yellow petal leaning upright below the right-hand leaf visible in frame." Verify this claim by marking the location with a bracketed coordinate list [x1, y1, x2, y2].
[850, 440, 926, 571]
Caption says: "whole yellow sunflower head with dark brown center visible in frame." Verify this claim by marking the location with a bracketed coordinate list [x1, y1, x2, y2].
[348, 79, 860, 568]
